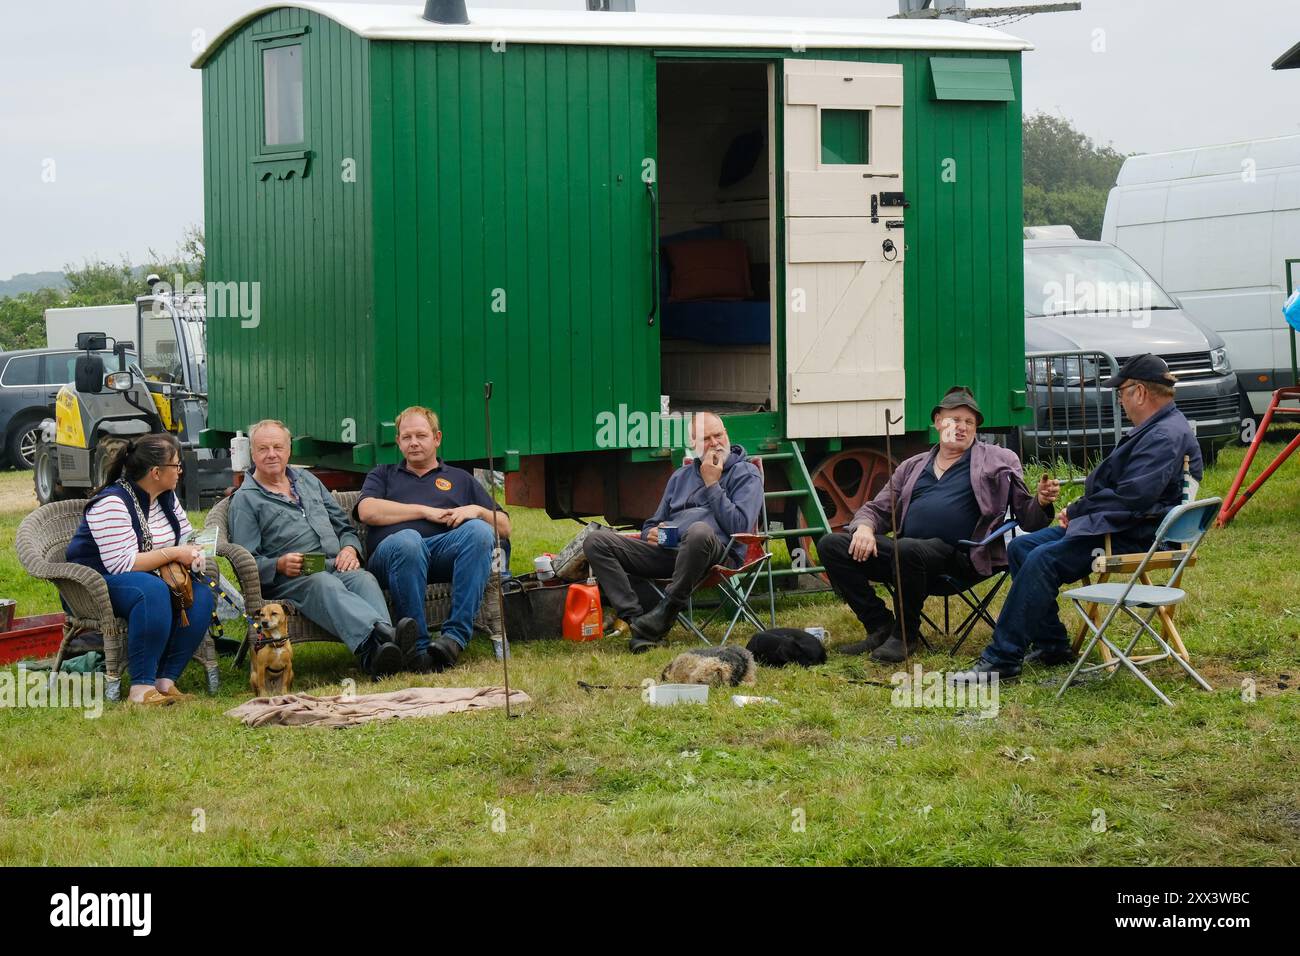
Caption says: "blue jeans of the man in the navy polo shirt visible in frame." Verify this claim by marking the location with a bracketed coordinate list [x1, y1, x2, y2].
[369, 518, 495, 650]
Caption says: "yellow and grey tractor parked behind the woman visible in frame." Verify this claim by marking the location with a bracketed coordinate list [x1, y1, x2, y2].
[34, 276, 230, 510]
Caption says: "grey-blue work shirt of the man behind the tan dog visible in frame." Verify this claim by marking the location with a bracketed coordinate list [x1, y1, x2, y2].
[229, 468, 365, 585]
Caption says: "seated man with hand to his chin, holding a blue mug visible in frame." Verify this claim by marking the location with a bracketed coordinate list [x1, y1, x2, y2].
[582, 412, 763, 654]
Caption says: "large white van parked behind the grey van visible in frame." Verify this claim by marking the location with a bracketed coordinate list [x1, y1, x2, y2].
[1101, 135, 1300, 415]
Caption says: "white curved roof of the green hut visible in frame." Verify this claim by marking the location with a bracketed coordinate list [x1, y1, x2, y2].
[194, 0, 1034, 68]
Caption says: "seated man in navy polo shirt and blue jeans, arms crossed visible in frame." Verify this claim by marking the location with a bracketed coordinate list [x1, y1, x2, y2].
[356, 405, 510, 671]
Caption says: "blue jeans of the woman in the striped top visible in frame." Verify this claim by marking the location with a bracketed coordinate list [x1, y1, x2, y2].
[104, 571, 216, 687]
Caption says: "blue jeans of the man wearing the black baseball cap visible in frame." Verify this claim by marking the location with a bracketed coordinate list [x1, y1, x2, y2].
[980, 525, 1152, 666]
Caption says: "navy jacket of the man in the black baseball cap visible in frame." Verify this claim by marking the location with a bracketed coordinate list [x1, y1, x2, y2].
[1065, 402, 1203, 537]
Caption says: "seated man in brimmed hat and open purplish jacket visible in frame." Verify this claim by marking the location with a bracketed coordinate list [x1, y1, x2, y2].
[818, 385, 1061, 663]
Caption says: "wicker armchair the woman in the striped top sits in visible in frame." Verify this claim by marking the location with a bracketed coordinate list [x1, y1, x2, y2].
[17, 499, 220, 700]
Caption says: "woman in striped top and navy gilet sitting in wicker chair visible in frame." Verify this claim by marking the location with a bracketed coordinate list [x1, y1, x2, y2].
[68, 433, 215, 706]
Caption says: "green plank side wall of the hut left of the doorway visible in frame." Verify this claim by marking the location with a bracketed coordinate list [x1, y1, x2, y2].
[371, 42, 659, 459]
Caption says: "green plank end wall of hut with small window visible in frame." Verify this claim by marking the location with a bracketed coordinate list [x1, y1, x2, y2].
[203, 8, 377, 452]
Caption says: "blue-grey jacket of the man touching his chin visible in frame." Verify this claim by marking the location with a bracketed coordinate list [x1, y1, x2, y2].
[641, 445, 763, 563]
